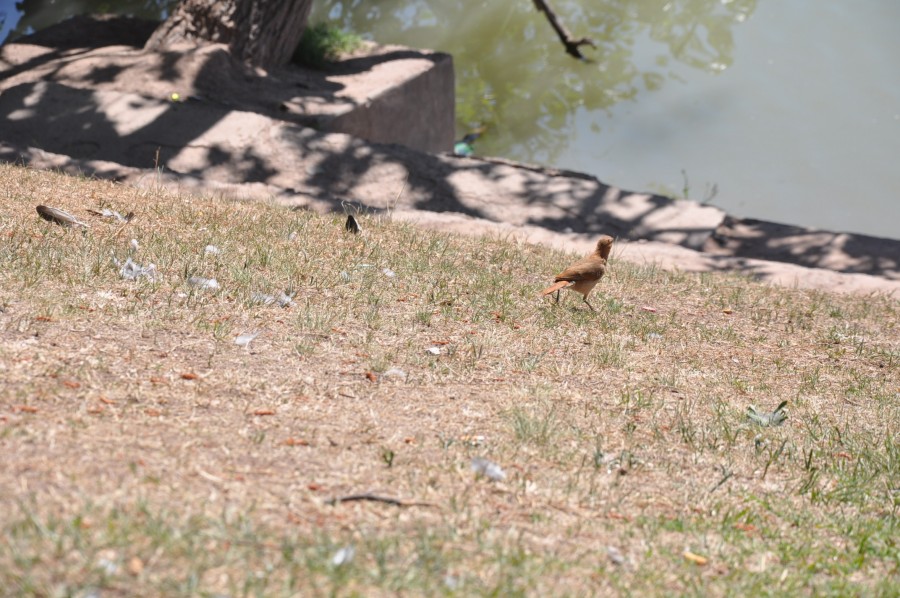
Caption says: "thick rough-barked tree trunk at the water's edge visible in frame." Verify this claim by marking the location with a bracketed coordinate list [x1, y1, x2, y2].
[144, 0, 312, 68]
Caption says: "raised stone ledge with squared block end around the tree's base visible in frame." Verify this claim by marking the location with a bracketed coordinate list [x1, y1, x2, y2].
[0, 17, 456, 152]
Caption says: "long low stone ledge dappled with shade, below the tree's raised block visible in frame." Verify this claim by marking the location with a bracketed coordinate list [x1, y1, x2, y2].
[0, 82, 724, 248]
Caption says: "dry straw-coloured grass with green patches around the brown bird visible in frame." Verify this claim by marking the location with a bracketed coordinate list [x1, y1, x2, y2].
[0, 166, 900, 596]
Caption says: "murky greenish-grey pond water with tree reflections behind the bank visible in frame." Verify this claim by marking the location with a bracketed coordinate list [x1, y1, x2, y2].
[0, 0, 900, 238]
